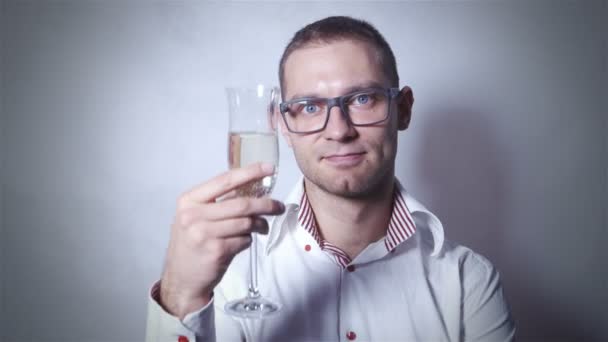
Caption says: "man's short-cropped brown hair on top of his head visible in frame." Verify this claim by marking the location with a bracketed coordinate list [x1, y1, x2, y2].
[279, 16, 399, 93]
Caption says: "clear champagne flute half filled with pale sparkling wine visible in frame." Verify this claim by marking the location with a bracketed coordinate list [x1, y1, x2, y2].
[225, 84, 280, 318]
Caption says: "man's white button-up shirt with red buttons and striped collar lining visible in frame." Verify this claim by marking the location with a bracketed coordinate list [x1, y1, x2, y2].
[146, 181, 515, 342]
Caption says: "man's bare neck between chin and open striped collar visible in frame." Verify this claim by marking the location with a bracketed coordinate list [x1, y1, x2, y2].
[304, 175, 395, 259]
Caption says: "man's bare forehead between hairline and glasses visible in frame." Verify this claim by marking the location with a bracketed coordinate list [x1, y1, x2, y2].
[283, 40, 388, 99]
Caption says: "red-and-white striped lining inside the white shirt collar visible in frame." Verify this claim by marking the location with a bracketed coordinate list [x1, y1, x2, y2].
[298, 186, 416, 268]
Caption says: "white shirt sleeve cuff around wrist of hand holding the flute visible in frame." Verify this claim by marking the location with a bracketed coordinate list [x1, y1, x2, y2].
[146, 281, 242, 342]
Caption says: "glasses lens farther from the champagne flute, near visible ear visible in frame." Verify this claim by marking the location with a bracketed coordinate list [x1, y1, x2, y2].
[345, 89, 389, 125]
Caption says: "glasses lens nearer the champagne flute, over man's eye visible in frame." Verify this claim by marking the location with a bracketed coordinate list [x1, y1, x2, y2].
[283, 99, 327, 133]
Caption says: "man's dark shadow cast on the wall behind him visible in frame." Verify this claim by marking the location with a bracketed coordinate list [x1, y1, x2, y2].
[415, 108, 593, 341]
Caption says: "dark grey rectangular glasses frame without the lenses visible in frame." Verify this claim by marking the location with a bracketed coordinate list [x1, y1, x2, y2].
[279, 87, 400, 134]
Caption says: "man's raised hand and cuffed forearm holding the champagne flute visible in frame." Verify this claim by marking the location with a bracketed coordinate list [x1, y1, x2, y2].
[146, 163, 285, 342]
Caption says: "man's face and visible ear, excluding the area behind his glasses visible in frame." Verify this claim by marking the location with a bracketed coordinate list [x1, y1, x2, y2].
[283, 40, 413, 198]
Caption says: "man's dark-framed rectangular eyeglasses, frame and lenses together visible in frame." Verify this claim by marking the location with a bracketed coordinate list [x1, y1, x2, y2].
[279, 88, 399, 133]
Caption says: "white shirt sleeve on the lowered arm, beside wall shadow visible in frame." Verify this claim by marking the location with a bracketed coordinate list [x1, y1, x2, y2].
[462, 254, 515, 341]
